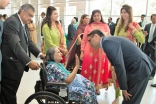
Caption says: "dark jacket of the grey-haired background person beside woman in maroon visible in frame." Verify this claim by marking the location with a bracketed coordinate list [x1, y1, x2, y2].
[67, 23, 76, 40]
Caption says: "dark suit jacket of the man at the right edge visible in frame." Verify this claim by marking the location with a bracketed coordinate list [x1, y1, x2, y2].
[143, 23, 156, 51]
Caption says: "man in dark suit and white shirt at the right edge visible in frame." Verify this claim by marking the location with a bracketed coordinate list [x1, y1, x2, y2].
[143, 14, 156, 80]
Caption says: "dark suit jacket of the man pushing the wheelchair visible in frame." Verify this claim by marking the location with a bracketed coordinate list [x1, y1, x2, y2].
[2, 14, 40, 80]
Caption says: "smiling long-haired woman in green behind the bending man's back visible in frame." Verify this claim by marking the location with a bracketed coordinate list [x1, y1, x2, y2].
[114, 4, 145, 44]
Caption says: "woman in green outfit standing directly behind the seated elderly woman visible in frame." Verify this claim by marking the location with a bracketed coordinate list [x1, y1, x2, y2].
[42, 6, 67, 63]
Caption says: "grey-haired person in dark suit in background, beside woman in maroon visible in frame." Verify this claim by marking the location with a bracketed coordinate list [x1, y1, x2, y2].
[67, 19, 76, 50]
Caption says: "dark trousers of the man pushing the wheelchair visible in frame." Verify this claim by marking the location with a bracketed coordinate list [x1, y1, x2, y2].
[0, 77, 21, 104]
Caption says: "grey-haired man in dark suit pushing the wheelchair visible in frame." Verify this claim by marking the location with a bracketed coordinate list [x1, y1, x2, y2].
[0, 4, 45, 104]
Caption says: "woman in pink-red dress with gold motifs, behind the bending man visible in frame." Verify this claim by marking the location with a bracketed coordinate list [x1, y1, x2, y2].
[80, 10, 110, 94]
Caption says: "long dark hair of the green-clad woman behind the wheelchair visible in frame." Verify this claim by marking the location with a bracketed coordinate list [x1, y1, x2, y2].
[45, 6, 59, 29]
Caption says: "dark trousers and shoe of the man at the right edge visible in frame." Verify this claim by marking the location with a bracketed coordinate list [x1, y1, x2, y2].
[144, 44, 156, 77]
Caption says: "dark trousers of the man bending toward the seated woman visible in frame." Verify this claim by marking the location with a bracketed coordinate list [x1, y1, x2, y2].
[122, 77, 149, 104]
